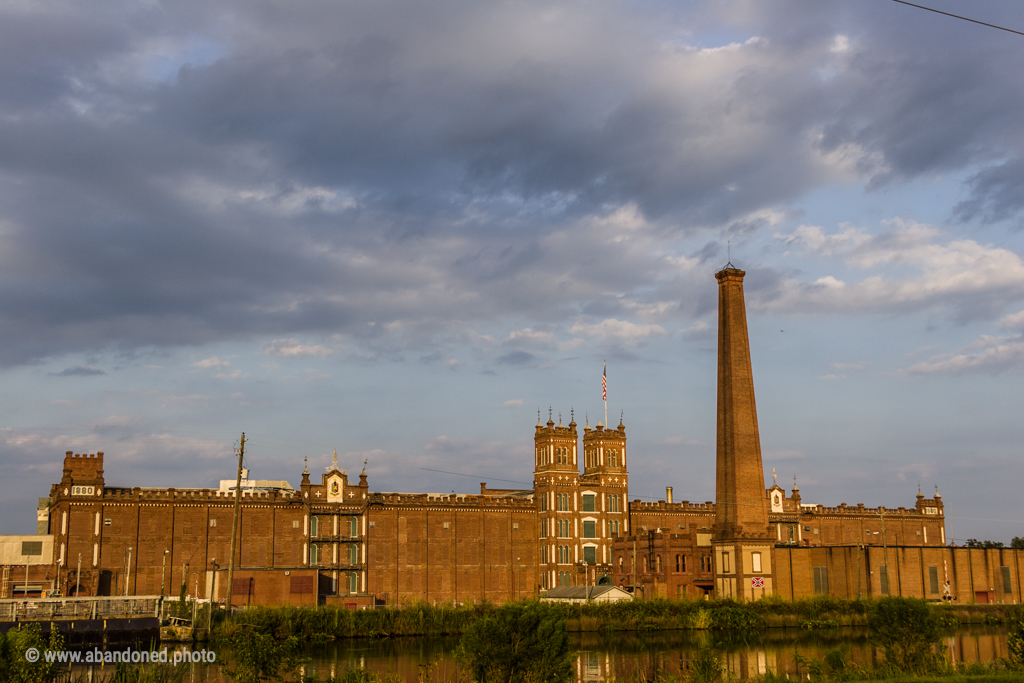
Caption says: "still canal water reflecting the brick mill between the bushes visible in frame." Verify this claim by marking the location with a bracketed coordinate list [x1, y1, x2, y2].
[68, 626, 1008, 683]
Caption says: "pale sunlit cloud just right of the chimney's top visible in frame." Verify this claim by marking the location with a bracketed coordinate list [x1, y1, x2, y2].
[770, 219, 1024, 322]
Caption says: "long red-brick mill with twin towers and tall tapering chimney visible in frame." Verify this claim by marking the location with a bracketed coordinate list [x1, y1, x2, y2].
[0, 265, 1022, 606]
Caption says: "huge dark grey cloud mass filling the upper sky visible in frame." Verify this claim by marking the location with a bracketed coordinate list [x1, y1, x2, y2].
[0, 2, 1024, 365]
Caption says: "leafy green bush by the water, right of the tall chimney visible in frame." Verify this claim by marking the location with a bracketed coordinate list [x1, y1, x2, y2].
[867, 597, 939, 674]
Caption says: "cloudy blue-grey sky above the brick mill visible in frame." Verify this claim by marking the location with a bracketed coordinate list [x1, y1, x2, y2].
[0, 0, 1024, 543]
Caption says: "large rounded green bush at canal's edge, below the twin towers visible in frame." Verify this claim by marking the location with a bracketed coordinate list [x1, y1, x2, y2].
[456, 601, 575, 683]
